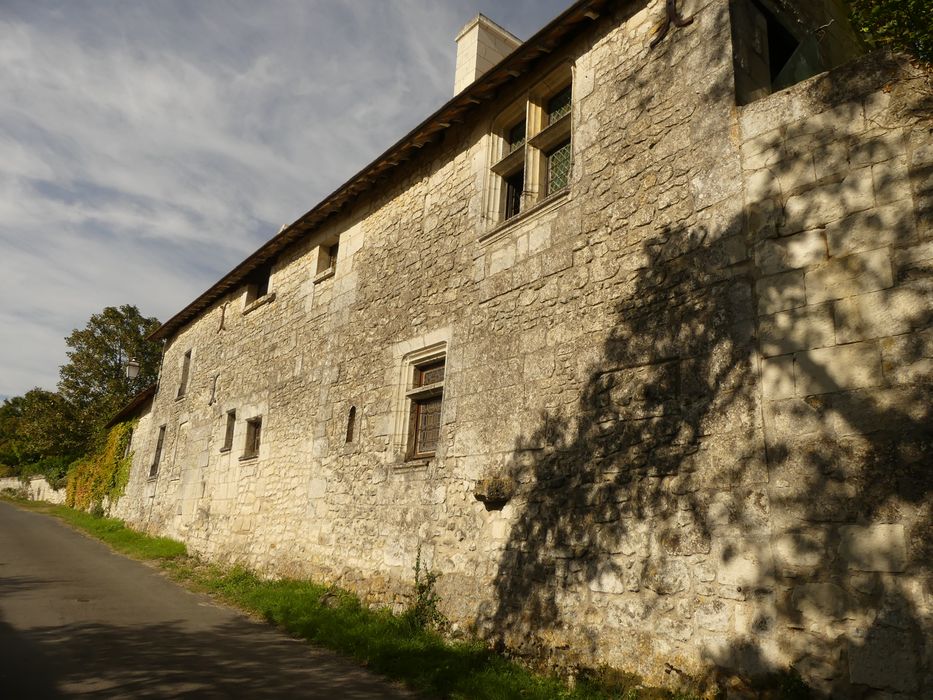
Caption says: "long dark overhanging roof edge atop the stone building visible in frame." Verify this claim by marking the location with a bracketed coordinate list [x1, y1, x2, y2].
[149, 0, 613, 340]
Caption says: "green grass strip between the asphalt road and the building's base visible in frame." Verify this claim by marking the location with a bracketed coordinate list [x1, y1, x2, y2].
[4, 497, 692, 700]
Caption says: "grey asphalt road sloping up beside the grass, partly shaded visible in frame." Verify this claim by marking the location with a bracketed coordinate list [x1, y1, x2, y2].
[0, 502, 413, 700]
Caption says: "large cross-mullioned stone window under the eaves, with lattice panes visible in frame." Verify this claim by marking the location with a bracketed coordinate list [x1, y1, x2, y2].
[488, 66, 573, 226]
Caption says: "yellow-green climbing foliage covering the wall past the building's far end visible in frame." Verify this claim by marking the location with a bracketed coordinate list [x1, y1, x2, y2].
[65, 422, 134, 514]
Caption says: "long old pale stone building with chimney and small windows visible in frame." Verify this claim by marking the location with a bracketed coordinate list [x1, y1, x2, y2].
[115, 0, 933, 697]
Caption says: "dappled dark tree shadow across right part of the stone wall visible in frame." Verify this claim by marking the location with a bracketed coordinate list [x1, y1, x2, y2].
[480, 17, 933, 694]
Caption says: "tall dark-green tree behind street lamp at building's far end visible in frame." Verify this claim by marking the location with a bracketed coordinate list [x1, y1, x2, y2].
[58, 304, 161, 446]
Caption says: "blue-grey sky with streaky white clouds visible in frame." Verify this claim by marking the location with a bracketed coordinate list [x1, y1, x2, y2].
[0, 0, 571, 398]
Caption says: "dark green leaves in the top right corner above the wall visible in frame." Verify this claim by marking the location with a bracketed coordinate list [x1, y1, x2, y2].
[848, 0, 933, 63]
